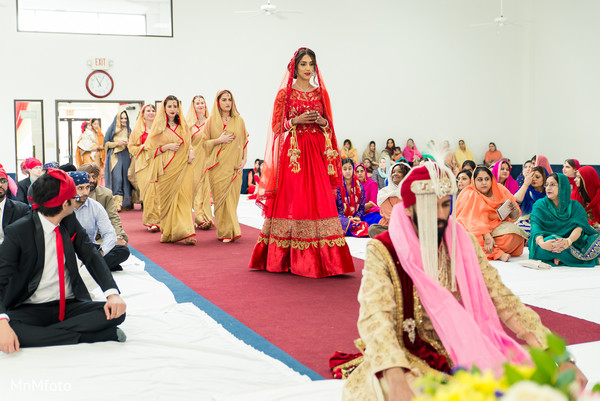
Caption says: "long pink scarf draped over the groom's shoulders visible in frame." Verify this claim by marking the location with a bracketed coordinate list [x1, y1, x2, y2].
[389, 205, 529, 369]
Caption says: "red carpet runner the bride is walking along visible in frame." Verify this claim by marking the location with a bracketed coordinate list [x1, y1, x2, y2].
[120, 205, 600, 378]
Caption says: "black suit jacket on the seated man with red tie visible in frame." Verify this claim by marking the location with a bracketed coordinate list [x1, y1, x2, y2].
[0, 211, 118, 315]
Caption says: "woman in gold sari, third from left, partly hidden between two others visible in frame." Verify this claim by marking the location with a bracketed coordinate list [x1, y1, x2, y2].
[186, 95, 213, 230]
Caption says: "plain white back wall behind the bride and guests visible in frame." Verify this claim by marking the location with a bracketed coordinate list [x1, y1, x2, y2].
[0, 0, 600, 171]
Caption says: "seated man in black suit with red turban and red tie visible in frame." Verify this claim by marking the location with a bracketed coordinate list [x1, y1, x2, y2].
[0, 168, 126, 353]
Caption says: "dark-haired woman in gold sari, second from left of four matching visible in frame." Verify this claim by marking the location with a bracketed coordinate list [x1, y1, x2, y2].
[146, 95, 196, 245]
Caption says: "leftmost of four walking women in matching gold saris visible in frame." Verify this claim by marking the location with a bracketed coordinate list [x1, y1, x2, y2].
[128, 104, 160, 232]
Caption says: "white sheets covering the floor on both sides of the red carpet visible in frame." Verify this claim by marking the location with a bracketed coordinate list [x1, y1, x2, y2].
[0, 196, 600, 401]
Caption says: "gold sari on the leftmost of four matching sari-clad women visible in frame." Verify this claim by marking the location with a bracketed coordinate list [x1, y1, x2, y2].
[127, 105, 160, 227]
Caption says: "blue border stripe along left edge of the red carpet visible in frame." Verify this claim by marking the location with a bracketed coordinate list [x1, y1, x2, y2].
[129, 245, 325, 380]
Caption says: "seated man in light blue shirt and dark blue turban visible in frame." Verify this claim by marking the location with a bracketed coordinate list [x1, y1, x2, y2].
[68, 171, 129, 271]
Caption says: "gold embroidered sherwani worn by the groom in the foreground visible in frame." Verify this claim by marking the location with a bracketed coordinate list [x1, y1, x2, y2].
[343, 235, 549, 401]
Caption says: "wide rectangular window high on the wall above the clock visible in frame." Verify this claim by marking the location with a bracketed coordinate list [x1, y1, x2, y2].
[17, 0, 173, 36]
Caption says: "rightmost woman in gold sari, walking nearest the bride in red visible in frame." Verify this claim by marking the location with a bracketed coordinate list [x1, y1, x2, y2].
[202, 90, 248, 242]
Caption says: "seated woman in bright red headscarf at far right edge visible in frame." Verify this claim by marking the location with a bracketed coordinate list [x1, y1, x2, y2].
[571, 166, 600, 231]
